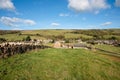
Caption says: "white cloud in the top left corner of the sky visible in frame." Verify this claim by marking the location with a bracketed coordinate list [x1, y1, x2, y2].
[0, 0, 15, 10]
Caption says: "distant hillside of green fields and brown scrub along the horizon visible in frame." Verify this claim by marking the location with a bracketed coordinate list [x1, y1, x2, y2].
[0, 29, 120, 41]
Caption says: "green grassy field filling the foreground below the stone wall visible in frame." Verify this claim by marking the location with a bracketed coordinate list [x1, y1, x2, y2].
[0, 49, 120, 80]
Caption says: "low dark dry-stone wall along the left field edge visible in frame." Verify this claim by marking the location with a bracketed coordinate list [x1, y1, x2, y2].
[0, 44, 48, 58]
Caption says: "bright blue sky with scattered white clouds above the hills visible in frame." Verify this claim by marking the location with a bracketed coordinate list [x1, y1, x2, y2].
[0, 0, 120, 30]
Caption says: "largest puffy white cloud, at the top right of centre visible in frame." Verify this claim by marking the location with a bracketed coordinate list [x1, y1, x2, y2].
[68, 0, 110, 13]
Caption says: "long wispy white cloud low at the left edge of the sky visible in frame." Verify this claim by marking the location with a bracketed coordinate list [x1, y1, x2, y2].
[0, 16, 36, 27]
